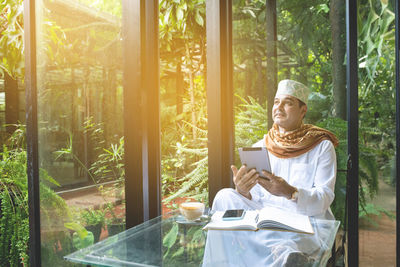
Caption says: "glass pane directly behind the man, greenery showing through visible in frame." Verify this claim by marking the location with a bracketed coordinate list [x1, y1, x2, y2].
[233, 0, 347, 266]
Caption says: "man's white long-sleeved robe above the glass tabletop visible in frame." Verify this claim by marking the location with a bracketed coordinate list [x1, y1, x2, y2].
[212, 140, 336, 219]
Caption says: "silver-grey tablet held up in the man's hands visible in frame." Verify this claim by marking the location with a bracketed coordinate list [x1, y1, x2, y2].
[239, 147, 271, 178]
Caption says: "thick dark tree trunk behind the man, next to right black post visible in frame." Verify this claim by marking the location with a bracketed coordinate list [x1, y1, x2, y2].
[329, 0, 347, 120]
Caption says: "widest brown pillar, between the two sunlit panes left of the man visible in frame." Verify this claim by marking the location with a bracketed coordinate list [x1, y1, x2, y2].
[122, 0, 161, 228]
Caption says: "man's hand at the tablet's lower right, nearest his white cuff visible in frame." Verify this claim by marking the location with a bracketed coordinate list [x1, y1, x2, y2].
[258, 171, 296, 199]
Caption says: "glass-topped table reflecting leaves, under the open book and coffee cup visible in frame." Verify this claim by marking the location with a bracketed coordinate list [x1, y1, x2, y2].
[65, 211, 340, 266]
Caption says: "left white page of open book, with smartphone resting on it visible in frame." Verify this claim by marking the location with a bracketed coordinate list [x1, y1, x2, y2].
[203, 210, 258, 230]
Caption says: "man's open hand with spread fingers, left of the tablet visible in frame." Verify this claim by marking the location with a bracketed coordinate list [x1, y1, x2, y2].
[231, 165, 259, 199]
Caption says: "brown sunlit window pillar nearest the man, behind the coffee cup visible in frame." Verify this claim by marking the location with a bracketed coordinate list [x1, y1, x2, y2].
[206, 0, 234, 205]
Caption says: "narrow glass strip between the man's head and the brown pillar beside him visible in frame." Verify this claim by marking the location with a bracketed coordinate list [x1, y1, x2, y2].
[232, 1, 273, 151]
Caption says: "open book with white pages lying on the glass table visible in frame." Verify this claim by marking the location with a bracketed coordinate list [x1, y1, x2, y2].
[203, 206, 314, 234]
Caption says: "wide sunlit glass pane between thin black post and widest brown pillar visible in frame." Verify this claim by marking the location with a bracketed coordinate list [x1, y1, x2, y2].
[36, 0, 125, 266]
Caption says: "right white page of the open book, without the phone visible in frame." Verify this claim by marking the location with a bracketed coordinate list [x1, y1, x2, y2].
[258, 207, 314, 234]
